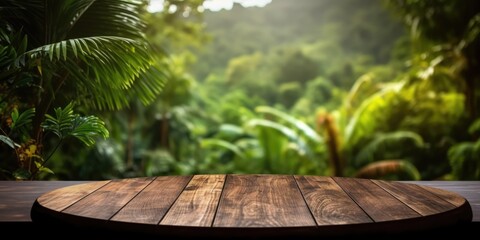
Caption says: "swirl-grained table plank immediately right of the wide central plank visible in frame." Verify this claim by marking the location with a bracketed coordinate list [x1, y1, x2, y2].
[295, 176, 373, 225]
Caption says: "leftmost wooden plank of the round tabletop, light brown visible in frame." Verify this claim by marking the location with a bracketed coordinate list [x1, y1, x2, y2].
[37, 181, 109, 212]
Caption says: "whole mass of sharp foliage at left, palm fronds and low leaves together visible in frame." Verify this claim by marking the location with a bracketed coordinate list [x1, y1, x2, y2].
[0, 0, 164, 178]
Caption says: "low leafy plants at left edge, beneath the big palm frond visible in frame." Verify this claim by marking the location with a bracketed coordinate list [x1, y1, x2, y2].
[0, 103, 109, 180]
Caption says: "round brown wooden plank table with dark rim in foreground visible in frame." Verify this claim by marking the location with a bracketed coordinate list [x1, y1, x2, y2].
[31, 175, 472, 237]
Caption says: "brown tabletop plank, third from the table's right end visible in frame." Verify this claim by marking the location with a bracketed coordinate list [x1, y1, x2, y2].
[333, 177, 420, 222]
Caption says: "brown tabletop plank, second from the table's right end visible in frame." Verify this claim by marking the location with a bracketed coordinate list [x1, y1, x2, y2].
[373, 180, 455, 216]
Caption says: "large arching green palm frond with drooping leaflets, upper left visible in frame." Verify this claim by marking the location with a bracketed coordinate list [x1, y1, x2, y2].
[27, 36, 165, 109]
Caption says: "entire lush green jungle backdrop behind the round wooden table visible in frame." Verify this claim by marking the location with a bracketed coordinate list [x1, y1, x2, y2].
[0, 0, 480, 180]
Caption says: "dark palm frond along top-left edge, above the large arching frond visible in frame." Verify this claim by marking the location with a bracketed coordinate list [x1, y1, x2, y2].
[0, 0, 145, 44]
